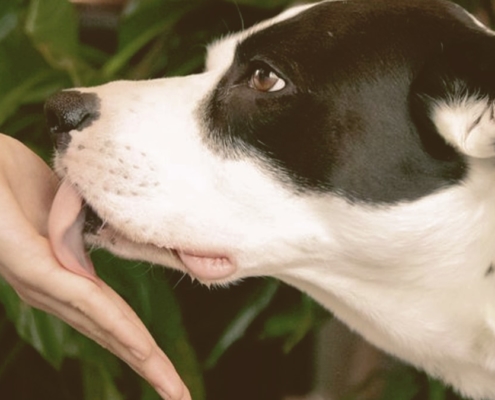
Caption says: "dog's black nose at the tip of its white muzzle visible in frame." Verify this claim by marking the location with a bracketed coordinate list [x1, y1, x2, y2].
[45, 90, 100, 150]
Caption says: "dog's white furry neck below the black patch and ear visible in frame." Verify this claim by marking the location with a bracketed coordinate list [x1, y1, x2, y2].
[277, 159, 495, 394]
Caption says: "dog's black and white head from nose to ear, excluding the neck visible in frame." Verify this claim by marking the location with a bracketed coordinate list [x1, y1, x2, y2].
[46, 0, 495, 281]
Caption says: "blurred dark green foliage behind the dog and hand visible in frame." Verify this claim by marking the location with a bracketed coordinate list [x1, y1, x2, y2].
[0, 0, 493, 400]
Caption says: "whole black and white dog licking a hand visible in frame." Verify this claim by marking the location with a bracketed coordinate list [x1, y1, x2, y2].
[46, 0, 495, 399]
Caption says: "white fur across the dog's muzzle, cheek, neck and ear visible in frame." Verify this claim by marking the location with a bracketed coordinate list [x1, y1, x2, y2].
[56, 3, 495, 399]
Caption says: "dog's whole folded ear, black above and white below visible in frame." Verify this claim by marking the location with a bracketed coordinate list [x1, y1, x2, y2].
[412, 31, 495, 158]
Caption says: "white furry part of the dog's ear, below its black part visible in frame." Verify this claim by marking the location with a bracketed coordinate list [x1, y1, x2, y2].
[431, 96, 495, 158]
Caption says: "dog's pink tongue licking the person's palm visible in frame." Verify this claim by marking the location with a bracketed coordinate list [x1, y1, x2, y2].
[48, 181, 96, 280]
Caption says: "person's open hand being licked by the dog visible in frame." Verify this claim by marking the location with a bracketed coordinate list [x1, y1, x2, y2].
[0, 134, 191, 400]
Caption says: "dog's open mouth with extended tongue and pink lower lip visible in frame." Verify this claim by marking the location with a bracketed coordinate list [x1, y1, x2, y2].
[48, 180, 237, 283]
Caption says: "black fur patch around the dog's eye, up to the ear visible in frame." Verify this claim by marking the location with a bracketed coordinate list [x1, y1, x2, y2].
[203, 0, 495, 203]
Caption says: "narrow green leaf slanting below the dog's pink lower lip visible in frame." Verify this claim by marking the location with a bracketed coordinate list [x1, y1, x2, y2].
[204, 279, 279, 369]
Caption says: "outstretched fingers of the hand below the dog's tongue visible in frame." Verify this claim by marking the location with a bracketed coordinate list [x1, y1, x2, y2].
[10, 248, 190, 400]
